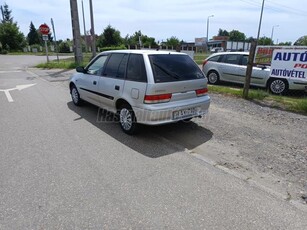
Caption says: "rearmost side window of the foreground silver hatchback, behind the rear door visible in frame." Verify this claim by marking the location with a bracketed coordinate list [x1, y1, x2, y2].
[126, 54, 147, 82]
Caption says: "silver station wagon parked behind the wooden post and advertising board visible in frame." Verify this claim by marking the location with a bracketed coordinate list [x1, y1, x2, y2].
[202, 52, 306, 94]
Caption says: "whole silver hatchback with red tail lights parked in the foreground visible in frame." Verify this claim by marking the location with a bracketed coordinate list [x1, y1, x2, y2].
[69, 50, 210, 134]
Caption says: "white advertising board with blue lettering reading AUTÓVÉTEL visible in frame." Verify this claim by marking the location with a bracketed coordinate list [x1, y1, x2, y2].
[270, 49, 307, 81]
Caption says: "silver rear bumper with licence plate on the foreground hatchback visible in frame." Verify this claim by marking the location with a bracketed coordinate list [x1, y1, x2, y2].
[133, 95, 210, 125]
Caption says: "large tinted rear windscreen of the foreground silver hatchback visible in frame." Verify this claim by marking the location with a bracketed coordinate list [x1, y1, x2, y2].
[149, 54, 205, 83]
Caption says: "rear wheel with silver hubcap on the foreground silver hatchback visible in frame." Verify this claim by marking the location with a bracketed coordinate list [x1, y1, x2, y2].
[118, 104, 138, 135]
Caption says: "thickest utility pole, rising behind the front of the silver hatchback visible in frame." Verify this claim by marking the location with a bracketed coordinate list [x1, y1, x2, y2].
[70, 0, 83, 65]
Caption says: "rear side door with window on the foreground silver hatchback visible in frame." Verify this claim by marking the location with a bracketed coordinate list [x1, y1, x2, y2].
[99, 53, 128, 112]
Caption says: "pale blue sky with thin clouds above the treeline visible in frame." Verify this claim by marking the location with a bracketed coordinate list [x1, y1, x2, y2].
[4, 0, 307, 43]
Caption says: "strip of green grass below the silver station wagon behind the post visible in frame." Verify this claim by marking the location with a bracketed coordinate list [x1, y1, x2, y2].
[208, 85, 307, 115]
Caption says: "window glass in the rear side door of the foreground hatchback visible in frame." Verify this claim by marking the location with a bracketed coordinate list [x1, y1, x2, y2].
[103, 53, 127, 78]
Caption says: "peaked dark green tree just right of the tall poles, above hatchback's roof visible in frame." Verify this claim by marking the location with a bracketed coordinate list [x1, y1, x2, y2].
[97, 25, 123, 47]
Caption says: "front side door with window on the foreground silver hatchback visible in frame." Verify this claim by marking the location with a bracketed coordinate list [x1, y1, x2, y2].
[76, 55, 107, 106]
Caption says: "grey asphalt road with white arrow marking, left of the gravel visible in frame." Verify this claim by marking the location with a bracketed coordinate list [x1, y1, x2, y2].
[0, 56, 307, 230]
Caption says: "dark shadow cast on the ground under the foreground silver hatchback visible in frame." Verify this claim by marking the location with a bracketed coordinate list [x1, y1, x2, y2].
[67, 102, 213, 158]
